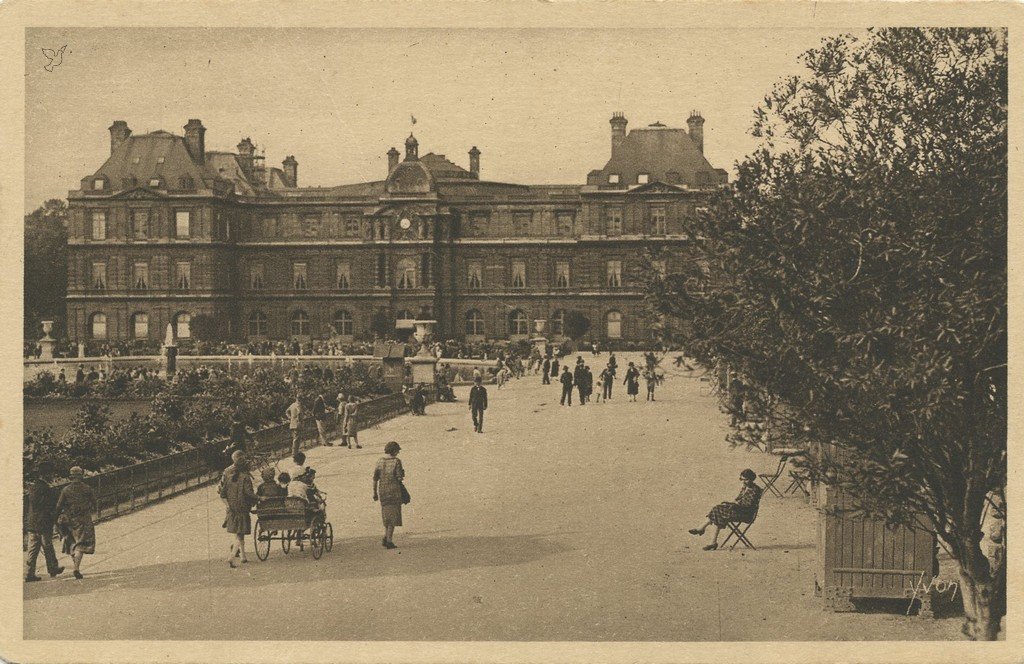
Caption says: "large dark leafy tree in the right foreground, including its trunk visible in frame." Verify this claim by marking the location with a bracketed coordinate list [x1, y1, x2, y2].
[650, 29, 1008, 639]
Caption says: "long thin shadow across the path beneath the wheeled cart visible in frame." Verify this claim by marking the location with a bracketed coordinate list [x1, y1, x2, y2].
[25, 534, 574, 600]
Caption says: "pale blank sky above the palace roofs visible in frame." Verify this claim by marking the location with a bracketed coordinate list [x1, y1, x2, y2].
[26, 28, 843, 206]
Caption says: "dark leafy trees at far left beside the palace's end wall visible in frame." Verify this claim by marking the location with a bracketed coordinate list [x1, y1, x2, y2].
[24, 199, 68, 340]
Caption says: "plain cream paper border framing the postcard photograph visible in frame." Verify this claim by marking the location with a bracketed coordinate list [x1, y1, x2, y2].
[0, 0, 1024, 664]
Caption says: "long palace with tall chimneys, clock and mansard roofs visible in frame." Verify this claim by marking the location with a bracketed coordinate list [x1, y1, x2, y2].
[68, 113, 727, 341]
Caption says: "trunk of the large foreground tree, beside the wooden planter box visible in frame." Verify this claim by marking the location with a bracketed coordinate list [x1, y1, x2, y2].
[959, 541, 1007, 640]
